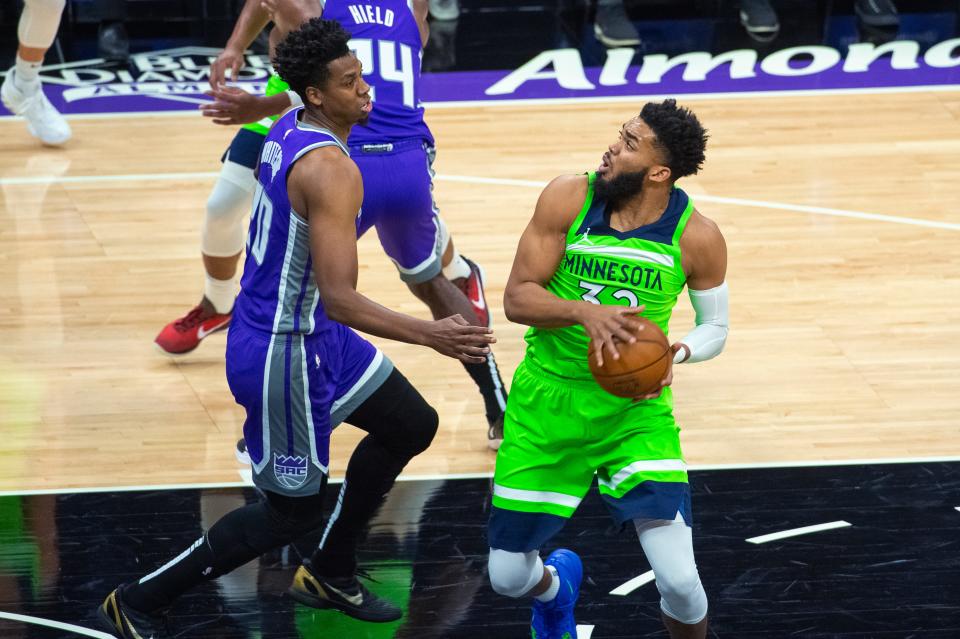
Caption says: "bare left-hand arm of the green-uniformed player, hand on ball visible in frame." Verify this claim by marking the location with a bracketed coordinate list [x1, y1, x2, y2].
[503, 175, 643, 365]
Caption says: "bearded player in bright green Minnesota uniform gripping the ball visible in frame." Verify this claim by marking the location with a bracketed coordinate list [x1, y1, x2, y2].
[488, 100, 727, 639]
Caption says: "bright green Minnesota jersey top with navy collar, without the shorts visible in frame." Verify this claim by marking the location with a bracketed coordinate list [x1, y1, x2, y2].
[525, 173, 693, 382]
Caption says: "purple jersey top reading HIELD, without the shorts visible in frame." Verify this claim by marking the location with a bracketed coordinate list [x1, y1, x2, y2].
[321, 0, 433, 146]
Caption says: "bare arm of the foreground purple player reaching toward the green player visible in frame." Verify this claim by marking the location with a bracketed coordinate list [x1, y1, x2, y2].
[287, 147, 495, 364]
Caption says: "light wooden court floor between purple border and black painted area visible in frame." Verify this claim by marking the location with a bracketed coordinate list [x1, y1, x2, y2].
[0, 91, 960, 491]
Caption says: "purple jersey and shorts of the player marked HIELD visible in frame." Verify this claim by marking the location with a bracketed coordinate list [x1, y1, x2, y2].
[323, 0, 444, 284]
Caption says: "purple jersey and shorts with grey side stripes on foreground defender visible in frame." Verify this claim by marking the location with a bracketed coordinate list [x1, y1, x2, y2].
[227, 108, 393, 496]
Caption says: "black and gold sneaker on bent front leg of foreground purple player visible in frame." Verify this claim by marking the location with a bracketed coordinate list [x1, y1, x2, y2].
[287, 565, 403, 623]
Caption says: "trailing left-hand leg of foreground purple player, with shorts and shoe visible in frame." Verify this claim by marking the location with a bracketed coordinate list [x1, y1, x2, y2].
[100, 324, 332, 637]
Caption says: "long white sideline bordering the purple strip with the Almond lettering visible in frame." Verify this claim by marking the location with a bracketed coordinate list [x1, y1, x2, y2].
[0, 82, 960, 122]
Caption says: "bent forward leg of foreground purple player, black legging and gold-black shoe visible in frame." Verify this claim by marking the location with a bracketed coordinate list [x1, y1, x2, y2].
[290, 327, 439, 621]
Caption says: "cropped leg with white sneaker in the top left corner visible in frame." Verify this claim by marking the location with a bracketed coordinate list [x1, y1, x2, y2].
[0, 0, 72, 145]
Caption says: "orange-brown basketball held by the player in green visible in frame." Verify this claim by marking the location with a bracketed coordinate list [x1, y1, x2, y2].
[588, 317, 672, 398]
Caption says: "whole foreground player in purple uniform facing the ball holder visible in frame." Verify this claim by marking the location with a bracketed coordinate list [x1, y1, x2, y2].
[98, 18, 494, 639]
